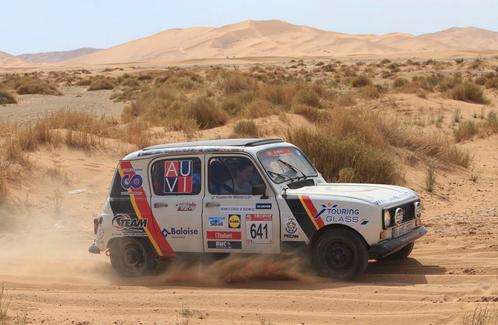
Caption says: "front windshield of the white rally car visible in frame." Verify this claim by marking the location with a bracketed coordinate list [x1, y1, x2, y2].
[258, 147, 317, 184]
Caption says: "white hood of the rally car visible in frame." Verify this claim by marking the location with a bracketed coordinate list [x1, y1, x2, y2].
[286, 183, 418, 206]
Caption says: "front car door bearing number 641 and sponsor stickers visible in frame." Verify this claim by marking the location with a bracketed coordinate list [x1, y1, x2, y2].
[202, 154, 280, 253]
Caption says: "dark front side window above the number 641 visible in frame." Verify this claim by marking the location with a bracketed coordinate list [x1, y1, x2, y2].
[208, 157, 263, 194]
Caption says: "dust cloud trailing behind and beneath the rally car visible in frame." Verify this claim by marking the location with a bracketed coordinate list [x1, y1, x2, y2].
[0, 208, 315, 286]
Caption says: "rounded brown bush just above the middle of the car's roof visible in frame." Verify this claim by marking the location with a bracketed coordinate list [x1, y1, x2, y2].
[188, 97, 228, 129]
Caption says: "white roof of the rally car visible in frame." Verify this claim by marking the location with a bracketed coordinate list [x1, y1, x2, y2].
[123, 138, 284, 160]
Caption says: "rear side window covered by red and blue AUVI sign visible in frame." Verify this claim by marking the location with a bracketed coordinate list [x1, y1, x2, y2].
[151, 158, 201, 195]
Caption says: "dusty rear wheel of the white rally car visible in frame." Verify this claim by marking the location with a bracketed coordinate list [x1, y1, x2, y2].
[109, 237, 158, 277]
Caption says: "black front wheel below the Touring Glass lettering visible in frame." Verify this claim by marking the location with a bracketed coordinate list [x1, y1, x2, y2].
[311, 228, 368, 280]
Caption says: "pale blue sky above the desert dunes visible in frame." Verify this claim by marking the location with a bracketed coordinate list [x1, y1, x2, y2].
[0, 0, 498, 55]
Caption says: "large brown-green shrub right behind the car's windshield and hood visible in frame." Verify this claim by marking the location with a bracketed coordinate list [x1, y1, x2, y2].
[288, 127, 401, 184]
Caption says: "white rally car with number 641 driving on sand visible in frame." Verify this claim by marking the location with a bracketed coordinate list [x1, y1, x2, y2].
[89, 139, 426, 279]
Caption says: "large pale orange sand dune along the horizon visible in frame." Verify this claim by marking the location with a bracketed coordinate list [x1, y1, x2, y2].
[70, 20, 498, 64]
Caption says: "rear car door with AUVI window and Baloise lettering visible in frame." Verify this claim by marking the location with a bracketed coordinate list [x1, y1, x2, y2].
[149, 155, 205, 252]
